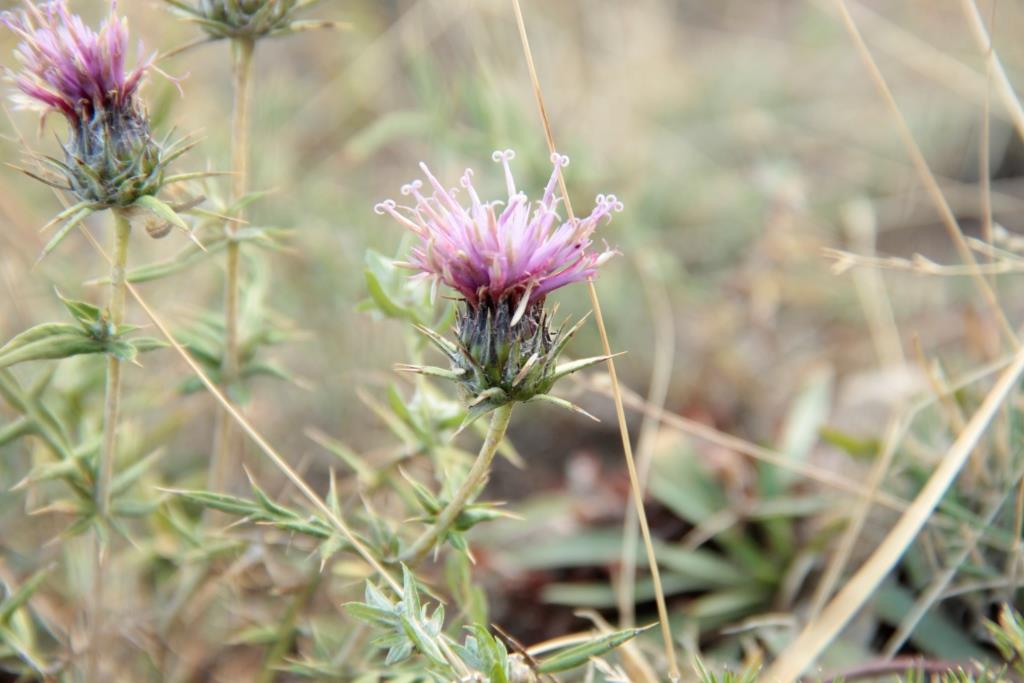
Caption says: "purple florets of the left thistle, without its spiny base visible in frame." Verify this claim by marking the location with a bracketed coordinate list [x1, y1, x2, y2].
[2, 0, 154, 123]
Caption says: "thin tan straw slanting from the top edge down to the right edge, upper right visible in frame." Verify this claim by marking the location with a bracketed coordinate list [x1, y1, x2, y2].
[836, 0, 1020, 348]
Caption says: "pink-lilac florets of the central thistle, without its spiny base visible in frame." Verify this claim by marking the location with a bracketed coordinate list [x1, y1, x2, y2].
[375, 150, 623, 308]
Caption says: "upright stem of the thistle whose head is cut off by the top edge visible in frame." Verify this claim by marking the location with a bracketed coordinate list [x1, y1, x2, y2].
[209, 38, 256, 490]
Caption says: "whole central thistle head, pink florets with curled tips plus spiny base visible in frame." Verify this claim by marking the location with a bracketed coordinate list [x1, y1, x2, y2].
[376, 151, 622, 414]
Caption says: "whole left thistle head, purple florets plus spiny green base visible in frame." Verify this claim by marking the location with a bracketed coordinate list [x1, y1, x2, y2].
[2, 0, 169, 208]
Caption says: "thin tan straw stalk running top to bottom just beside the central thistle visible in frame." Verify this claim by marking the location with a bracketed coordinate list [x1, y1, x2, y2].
[512, 0, 680, 681]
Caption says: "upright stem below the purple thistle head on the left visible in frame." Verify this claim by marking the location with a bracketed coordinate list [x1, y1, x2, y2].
[86, 210, 131, 681]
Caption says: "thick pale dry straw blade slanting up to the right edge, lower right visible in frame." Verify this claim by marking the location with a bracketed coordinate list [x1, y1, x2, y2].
[764, 327, 1024, 683]
